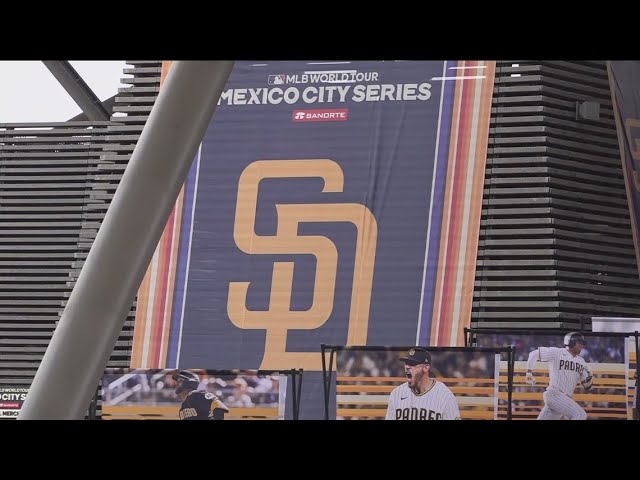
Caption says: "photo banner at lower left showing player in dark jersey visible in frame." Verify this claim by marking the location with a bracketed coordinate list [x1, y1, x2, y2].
[102, 368, 287, 420]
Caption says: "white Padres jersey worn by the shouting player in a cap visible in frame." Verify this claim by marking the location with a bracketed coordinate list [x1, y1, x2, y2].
[386, 381, 460, 420]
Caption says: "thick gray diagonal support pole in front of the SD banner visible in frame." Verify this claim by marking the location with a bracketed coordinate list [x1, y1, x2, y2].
[18, 61, 233, 420]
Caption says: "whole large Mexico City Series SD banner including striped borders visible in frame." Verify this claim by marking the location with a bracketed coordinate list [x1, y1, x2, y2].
[132, 61, 495, 413]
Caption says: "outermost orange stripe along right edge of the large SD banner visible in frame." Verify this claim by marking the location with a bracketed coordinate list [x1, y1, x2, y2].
[454, 62, 496, 345]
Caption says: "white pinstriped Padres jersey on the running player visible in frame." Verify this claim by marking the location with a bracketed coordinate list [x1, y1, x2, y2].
[538, 347, 591, 397]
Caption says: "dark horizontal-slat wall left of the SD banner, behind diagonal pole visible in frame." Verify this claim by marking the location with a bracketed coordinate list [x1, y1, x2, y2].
[0, 61, 160, 416]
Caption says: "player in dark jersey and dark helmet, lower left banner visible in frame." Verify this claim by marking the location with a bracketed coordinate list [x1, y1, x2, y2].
[172, 370, 229, 420]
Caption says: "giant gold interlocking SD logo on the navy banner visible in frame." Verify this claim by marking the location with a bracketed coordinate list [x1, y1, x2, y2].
[227, 159, 378, 370]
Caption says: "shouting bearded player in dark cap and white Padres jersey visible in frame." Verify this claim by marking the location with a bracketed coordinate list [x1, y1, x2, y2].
[386, 347, 460, 420]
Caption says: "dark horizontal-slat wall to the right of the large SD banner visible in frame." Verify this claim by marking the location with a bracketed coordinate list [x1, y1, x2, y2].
[471, 60, 640, 328]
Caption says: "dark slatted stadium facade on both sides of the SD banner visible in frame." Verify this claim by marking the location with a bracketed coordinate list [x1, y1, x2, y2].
[0, 60, 640, 420]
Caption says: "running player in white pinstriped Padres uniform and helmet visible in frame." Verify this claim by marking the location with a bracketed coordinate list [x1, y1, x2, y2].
[525, 332, 593, 420]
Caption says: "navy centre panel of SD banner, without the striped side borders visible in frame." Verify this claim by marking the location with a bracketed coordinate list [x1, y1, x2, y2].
[178, 62, 443, 370]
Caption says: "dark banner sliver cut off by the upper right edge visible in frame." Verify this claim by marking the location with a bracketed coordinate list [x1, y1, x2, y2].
[607, 61, 640, 272]
